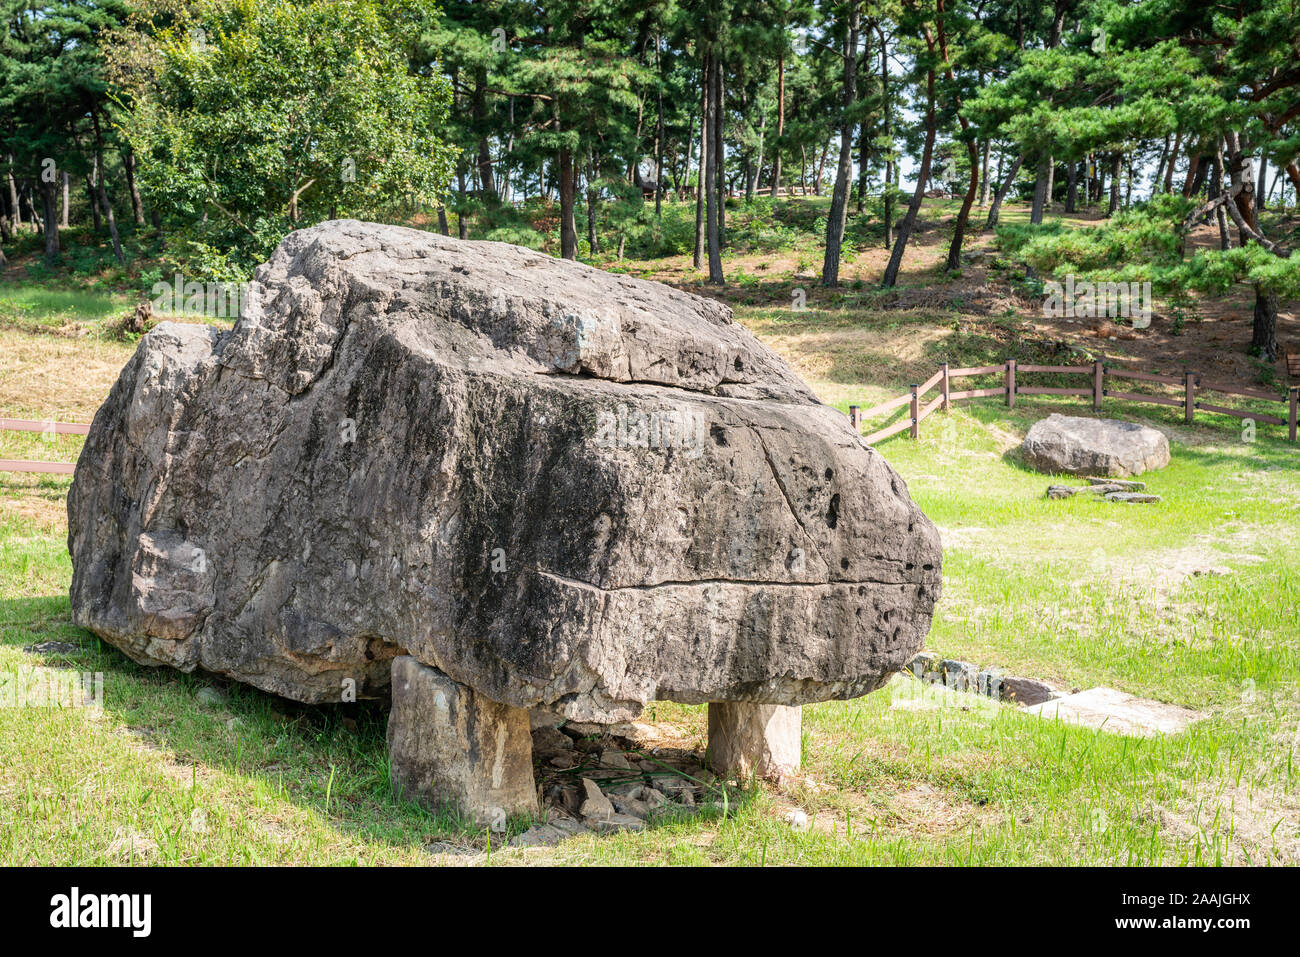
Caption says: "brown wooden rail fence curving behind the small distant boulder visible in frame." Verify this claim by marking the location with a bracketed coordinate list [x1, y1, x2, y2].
[849, 359, 1300, 443]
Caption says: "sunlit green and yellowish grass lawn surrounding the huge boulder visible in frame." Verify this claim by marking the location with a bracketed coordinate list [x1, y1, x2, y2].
[0, 204, 1300, 865]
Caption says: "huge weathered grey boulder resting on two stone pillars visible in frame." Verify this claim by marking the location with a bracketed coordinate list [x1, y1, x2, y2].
[68, 221, 940, 722]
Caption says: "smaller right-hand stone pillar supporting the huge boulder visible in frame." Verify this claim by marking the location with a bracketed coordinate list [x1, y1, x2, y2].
[709, 701, 801, 781]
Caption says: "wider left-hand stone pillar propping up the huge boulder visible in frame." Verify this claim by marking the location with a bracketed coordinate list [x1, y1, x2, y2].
[389, 655, 537, 830]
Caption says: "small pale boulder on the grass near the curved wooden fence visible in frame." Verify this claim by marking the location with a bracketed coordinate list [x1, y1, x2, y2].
[1021, 412, 1169, 476]
